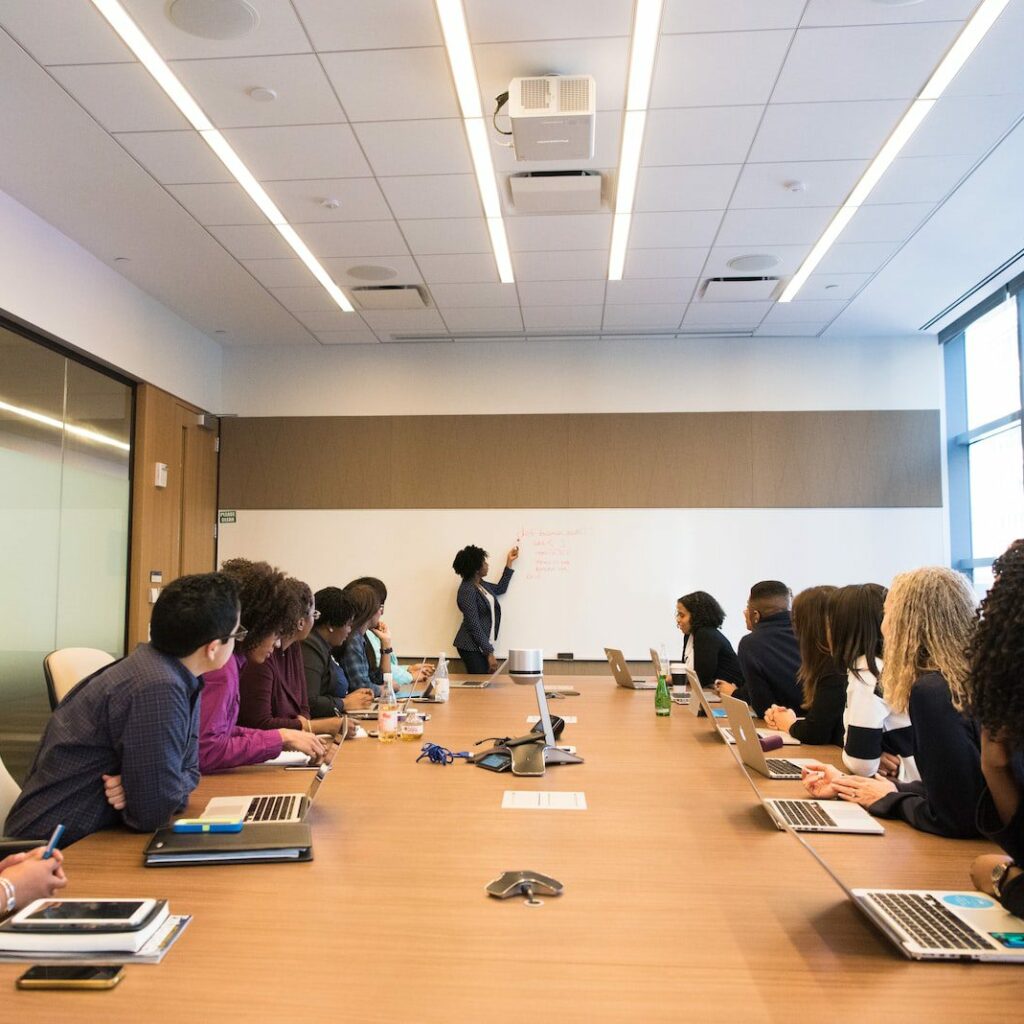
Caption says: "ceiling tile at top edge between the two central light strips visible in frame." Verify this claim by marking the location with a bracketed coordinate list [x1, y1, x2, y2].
[466, 0, 633, 42]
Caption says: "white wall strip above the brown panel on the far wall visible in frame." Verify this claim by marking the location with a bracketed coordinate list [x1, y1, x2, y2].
[222, 336, 943, 416]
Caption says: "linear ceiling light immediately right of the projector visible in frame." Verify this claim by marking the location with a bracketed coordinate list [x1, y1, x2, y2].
[608, 0, 663, 281]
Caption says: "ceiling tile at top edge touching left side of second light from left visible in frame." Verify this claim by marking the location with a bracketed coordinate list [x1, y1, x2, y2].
[293, 0, 442, 50]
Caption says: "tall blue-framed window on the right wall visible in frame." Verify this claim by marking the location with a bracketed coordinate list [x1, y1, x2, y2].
[940, 279, 1024, 595]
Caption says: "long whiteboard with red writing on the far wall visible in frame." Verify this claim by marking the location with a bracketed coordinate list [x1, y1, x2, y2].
[218, 508, 946, 659]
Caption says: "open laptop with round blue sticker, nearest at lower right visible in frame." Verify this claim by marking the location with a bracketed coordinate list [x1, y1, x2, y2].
[787, 828, 1024, 964]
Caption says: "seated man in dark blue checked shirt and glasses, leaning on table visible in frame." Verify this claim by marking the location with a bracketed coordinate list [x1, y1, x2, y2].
[4, 572, 245, 846]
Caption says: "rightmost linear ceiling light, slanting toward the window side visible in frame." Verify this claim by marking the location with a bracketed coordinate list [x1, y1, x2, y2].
[778, 0, 1010, 302]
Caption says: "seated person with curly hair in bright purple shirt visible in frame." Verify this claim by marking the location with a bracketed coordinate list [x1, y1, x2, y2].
[199, 558, 324, 775]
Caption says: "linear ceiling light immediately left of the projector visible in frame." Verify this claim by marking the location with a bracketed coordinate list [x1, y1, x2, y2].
[434, 0, 515, 285]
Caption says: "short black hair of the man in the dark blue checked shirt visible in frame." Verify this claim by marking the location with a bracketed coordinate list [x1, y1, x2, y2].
[150, 572, 240, 657]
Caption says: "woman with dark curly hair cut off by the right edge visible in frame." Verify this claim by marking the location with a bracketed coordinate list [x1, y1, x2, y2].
[968, 540, 1024, 918]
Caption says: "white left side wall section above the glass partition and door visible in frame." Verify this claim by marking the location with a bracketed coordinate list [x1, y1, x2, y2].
[0, 191, 221, 411]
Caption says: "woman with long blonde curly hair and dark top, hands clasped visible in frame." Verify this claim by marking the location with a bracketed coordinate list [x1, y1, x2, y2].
[815, 566, 984, 838]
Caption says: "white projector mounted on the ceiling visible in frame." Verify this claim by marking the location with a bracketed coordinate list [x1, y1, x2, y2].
[509, 75, 597, 160]
